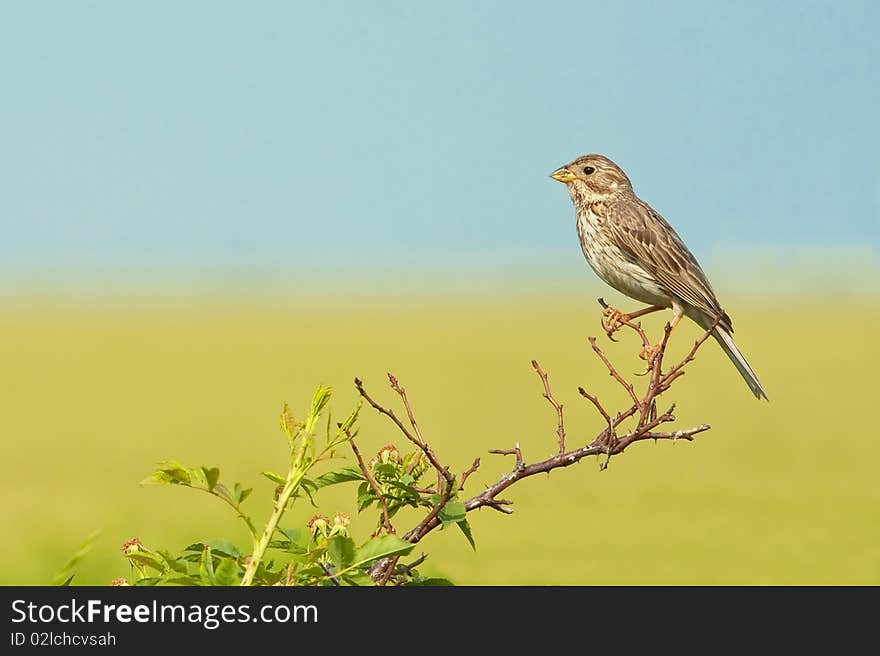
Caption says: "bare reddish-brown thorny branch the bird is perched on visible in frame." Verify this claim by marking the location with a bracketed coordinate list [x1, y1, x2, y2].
[352, 299, 720, 585]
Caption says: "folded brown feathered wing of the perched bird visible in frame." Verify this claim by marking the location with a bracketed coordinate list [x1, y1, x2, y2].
[608, 199, 723, 326]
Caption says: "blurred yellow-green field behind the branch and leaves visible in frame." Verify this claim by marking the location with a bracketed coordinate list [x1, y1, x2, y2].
[0, 293, 880, 584]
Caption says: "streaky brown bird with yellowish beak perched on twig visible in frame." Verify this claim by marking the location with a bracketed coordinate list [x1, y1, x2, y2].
[550, 154, 769, 400]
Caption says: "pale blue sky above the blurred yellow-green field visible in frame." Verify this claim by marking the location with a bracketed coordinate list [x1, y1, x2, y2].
[0, 2, 880, 284]
